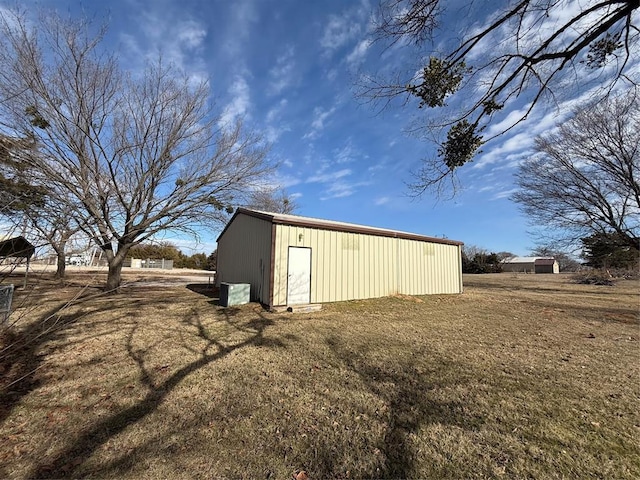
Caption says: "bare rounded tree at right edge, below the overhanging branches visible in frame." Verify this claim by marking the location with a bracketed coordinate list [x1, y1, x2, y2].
[513, 89, 640, 255]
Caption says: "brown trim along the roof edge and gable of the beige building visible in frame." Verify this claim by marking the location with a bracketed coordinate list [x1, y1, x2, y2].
[218, 207, 463, 245]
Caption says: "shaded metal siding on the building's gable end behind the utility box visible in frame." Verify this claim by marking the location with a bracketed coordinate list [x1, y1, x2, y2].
[217, 215, 271, 304]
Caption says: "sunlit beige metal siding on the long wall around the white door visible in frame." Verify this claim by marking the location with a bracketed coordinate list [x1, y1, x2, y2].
[273, 225, 462, 305]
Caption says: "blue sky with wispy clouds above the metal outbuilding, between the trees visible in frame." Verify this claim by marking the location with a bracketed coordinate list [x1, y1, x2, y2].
[15, 0, 640, 255]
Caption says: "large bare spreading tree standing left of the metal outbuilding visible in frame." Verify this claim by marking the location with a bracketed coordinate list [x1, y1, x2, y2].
[0, 10, 272, 291]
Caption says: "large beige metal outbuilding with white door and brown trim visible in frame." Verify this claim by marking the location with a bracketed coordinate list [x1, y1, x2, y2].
[216, 208, 462, 307]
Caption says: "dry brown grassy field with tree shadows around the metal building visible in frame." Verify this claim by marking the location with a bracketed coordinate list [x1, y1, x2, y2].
[0, 274, 640, 479]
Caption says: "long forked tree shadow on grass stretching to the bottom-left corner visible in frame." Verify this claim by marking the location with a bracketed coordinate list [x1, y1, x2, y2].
[29, 298, 284, 478]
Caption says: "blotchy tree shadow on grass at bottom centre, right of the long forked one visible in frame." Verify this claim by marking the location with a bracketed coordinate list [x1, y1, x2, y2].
[321, 337, 484, 478]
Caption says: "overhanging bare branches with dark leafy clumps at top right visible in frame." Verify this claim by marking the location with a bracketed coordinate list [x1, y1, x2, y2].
[361, 0, 640, 195]
